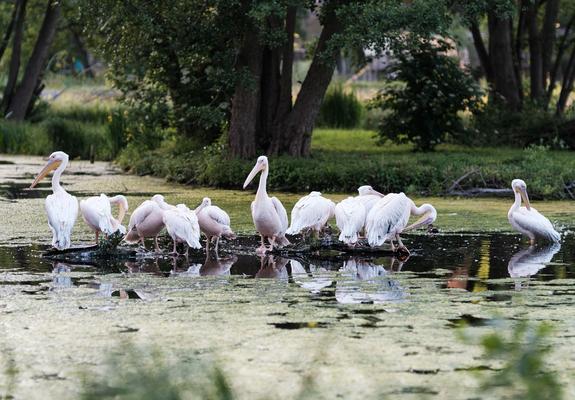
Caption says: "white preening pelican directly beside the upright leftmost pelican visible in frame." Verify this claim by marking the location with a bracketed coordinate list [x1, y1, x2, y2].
[80, 193, 128, 244]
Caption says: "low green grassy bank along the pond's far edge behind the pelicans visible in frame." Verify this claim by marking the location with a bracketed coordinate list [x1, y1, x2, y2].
[119, 129, 575, 199]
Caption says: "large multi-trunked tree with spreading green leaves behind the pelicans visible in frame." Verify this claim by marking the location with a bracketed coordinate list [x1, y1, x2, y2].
[83, 0, 447, 157]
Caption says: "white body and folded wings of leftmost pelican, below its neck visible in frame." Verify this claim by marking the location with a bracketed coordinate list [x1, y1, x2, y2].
[46, 192, 78, 250]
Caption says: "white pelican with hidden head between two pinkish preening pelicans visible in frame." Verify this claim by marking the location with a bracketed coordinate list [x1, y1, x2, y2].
[162, 204, 202, 254]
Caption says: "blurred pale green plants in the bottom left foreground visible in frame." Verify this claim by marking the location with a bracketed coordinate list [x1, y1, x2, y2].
[80, 344, 236, 400]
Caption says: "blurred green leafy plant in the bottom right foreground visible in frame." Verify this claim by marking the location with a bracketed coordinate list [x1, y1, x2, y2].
[463, 321, 563, 400]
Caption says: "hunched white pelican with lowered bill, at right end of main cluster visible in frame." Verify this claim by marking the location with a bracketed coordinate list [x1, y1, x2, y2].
[365, 193, 437, 253]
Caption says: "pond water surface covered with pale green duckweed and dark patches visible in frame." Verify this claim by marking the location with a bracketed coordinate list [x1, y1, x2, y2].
[0, 155, 575, 399]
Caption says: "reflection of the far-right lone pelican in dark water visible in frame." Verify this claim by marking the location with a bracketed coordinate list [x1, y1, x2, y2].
[507, 243, 561, 289]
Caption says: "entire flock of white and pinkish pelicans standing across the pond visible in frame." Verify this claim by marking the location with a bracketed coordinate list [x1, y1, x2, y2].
[30, 151, 560, 254]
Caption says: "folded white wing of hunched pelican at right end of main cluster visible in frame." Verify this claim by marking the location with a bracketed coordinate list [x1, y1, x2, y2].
[365, 193, 413, 246]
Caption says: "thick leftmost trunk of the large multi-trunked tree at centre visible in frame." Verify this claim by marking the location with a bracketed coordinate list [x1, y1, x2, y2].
[229, 32, 263, 158]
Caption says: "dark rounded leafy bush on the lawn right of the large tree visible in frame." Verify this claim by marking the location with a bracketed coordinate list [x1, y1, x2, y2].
[371, 40, 481, 151]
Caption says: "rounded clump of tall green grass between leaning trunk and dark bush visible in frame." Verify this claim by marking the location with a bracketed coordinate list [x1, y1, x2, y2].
[317, 85, 363, 128]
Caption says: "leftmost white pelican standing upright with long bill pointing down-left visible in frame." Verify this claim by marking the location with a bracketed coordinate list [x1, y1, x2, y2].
[30, 151, 78, 250]
